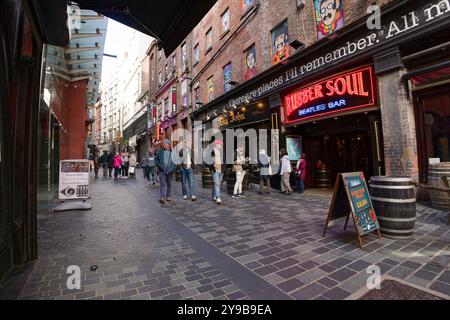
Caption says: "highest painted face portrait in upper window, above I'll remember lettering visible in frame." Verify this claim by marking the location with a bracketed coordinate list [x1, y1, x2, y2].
[314, 0, 345, 40]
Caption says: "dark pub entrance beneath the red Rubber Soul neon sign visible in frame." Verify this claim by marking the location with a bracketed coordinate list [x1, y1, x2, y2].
[287, 112, 384, 188]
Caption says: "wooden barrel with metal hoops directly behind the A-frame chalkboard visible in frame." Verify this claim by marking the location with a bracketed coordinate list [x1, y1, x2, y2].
[370, 177, 416, 239]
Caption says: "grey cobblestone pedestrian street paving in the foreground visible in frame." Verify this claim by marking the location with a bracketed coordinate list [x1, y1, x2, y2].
[0, 172, 450, 300]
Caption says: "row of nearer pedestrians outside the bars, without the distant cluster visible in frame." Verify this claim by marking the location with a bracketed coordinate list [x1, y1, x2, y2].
[141, 140, 306, 204]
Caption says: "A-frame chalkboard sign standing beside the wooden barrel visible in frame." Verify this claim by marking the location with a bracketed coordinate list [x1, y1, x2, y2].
[323, 172, 381, 248]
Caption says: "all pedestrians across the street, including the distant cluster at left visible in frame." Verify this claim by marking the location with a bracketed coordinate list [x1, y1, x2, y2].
[94, 140, 307, 204]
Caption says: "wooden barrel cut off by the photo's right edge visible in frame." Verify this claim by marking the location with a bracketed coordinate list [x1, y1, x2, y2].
[428, 162, 450, 211]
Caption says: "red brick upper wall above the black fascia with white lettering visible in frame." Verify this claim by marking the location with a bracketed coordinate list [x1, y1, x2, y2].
[188, 0, 393, 108]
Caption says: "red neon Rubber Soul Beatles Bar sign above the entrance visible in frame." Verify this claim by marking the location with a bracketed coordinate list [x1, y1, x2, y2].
[284, 67, 376, 124]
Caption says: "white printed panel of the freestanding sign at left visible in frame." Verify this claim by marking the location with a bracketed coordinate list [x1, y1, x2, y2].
[58, 160, 90, 200]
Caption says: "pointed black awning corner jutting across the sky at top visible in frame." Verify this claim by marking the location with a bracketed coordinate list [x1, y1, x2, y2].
[74, 0, 217, 56]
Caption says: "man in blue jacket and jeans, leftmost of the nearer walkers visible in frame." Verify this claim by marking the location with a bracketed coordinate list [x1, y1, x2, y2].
[155, 140, 176, 204]
